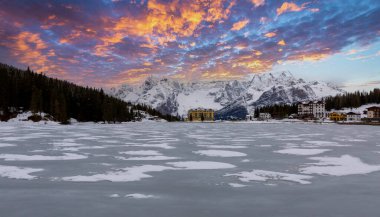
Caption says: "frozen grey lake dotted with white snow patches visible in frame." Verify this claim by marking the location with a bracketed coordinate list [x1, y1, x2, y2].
[0, 123, 380, 217]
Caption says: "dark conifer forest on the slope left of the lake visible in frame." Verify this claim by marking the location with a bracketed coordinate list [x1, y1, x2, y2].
[0, 63, 178, 123]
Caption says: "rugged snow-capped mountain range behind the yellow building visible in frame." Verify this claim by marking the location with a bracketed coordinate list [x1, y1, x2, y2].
[109, 72, 343, 118]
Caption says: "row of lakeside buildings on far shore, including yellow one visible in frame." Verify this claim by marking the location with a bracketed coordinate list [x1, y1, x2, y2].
[184, 101, 380, 125]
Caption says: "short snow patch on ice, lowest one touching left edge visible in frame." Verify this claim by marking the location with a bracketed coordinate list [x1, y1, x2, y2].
[0, 165, 44, 180]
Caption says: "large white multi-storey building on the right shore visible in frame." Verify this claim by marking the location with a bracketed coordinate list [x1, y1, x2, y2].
[298, 101, 326, 119]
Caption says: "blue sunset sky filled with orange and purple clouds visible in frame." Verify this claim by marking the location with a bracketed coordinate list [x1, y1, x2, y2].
[0, 0, 380, 90]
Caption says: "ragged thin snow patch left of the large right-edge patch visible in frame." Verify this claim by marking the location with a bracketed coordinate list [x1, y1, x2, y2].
[225, 170, 313, 184]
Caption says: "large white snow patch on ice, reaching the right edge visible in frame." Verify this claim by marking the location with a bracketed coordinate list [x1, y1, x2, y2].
[300, 155, 380, 176]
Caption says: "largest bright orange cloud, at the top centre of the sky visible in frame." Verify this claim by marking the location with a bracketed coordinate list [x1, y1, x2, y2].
[95, 0, 235, 56]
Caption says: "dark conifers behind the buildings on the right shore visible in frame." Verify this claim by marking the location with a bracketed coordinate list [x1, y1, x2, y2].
[255, 88, 380, 118]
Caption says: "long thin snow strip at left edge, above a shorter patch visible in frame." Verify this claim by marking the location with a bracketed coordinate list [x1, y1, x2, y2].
[0, 153, 88, 161]
